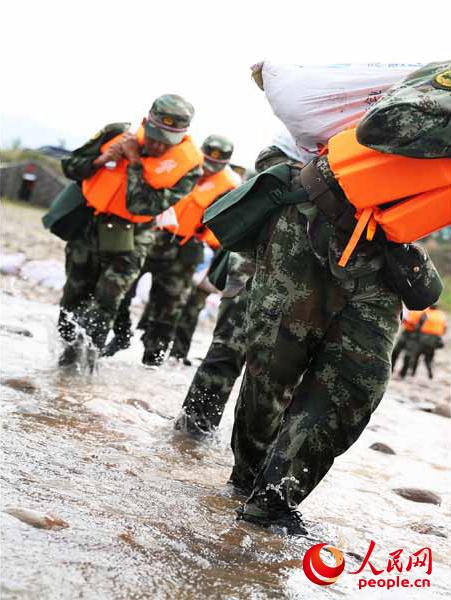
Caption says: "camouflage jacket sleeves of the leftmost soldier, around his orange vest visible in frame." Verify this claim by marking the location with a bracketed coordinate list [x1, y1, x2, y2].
[62, 123, 202, 216]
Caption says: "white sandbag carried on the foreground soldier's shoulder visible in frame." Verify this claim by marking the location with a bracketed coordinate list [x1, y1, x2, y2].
[262, 61, 421, 162]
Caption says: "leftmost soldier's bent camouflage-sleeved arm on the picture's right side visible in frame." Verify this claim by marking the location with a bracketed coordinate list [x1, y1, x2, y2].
[126, 163, 202, 217]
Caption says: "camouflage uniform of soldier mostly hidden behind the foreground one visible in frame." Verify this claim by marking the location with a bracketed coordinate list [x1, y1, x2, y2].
[175, 146, 297, 433]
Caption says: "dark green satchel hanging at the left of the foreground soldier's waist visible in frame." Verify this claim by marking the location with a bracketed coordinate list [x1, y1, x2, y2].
[203, 163, 308, 252]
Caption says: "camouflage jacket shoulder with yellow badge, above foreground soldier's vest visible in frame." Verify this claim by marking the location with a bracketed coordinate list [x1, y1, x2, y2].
[357, 61, 451, 158]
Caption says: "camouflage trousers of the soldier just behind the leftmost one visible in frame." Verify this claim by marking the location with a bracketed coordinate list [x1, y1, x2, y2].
[114, 231, 203, 354]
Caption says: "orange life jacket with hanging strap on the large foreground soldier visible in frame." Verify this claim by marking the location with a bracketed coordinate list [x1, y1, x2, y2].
[329, 129, 451, 267]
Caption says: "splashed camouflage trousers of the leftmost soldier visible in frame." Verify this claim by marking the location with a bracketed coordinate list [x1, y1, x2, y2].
[58, 222, 147, 348]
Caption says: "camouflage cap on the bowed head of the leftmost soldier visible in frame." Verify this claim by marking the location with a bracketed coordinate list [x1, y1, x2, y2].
[144, 94, 194, 146]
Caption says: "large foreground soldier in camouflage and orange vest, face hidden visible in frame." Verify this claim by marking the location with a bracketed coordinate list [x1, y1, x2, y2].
[205, 62, 451, 535]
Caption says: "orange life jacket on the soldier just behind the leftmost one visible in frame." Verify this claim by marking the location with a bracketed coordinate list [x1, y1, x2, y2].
[165, 166, 238, 248]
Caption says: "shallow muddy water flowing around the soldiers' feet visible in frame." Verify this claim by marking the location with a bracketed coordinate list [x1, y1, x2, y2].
[0, 295, 451, 600]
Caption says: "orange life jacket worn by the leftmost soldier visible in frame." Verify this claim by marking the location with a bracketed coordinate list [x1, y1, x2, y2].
[82, 127, 203, 223]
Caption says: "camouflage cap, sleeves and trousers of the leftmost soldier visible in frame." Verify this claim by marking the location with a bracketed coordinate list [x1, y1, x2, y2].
[59, 95, 202, 364]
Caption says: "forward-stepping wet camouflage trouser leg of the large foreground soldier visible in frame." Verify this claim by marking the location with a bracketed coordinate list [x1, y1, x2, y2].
[249, 292, 397, 508]
